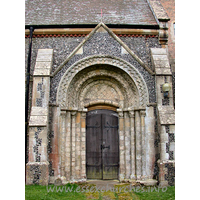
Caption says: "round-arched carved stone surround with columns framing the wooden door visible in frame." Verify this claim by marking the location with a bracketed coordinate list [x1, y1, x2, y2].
[53, 56, 154, 184]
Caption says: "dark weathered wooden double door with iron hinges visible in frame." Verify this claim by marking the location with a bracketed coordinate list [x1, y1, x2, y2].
[86, 110, 119, 179]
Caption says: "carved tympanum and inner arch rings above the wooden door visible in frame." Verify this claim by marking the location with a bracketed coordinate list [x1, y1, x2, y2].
[66, 66, 139, 108]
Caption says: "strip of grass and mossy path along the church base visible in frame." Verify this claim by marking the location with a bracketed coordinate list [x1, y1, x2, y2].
[25, 180, 175, 200]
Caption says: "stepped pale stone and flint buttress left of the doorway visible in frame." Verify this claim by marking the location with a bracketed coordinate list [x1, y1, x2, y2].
[26, 49, 53, 185]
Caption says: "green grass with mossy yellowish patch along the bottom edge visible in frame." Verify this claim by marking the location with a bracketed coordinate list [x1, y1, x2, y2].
[25, 184, 175, 200]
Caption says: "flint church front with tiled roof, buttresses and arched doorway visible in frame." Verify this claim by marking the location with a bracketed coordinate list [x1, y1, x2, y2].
[25, 0, 175, 186]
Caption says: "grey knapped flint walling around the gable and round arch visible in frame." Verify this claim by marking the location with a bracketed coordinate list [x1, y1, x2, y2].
[25, 33, 160, 103]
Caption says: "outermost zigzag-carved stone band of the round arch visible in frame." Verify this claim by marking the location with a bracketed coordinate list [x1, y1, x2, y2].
[57, 55, 148, 107]
